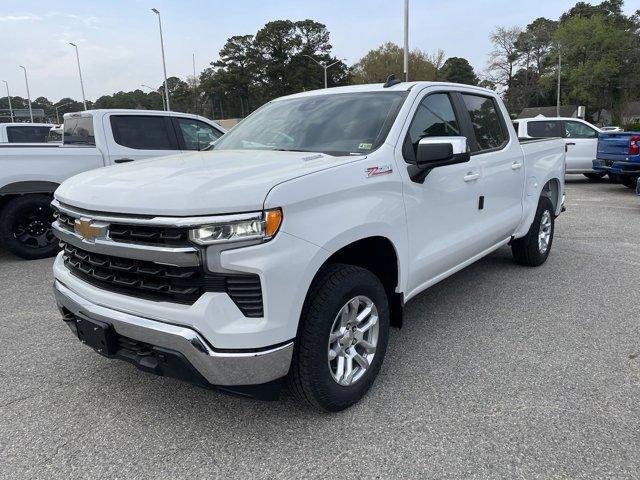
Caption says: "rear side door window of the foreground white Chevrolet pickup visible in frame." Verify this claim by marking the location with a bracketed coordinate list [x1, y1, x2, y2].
[462, 93, 509, 152]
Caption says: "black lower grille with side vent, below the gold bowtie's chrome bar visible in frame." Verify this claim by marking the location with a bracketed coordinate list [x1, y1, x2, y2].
[62, 243, 264, 317]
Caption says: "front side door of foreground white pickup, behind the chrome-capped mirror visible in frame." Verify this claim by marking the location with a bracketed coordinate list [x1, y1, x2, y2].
[397, 92, 482, 295]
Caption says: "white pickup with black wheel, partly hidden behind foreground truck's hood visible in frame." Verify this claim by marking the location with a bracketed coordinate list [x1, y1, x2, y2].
[0, 110, 224, 259]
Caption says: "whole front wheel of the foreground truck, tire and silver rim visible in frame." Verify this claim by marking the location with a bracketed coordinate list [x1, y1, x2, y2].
[288, 264, 389, 412]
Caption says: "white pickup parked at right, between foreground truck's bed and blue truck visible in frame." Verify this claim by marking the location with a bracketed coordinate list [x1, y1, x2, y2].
[513, 117, 605, 180]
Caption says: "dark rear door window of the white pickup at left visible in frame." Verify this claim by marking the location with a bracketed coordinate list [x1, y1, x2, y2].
[109, 115, 178, 150]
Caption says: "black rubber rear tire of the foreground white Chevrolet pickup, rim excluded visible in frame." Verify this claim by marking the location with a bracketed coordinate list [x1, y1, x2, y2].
[511, 197, 555, 267]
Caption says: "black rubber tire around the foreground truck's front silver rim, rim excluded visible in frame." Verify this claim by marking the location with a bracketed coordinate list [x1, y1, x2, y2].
[287, 264, 389, 412]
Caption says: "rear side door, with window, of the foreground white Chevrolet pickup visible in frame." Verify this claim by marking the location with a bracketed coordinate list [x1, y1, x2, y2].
[458, 93, 525, 251]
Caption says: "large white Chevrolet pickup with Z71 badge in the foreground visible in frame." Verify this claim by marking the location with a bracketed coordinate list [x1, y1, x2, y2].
[53, 81, 565, 411]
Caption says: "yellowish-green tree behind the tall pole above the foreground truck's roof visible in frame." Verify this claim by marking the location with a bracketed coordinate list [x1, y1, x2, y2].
[352, 42, 444, 83]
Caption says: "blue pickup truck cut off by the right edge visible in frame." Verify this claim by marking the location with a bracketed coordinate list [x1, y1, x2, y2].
[593, 132, 640, 189]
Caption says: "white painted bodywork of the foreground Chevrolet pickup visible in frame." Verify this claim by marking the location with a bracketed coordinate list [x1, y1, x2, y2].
[55, 82, 565, 348]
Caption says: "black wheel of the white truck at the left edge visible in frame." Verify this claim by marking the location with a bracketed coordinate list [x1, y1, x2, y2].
[0, 195, 59, 260]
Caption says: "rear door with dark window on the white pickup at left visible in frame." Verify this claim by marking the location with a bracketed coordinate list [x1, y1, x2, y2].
[104, 113, 180, 163]
